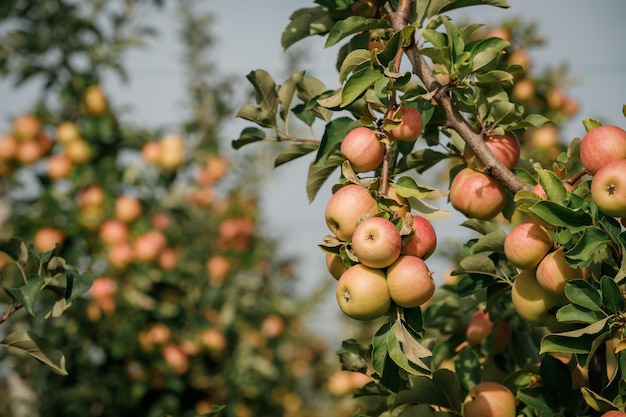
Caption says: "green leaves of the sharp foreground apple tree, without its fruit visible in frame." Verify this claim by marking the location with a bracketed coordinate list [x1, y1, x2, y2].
[233, 0, 626, 416]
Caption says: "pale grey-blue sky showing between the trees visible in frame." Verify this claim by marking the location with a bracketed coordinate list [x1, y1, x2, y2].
[0, 0, 626, 342]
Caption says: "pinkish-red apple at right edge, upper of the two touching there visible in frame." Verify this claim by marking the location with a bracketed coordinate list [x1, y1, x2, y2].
[580, 125, 626, 175]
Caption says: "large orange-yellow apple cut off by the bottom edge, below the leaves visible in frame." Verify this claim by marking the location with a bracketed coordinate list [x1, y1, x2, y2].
[463, 382, 517, 417]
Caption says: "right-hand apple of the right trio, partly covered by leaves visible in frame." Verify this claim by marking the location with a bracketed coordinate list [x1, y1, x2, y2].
[536, 247, 587, 295]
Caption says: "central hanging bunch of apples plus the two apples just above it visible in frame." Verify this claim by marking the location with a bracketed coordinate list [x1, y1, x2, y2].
[325, 106, 437, 320]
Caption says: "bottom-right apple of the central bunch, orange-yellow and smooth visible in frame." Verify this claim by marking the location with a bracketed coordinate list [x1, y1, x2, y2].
[387, 256, 435, 308]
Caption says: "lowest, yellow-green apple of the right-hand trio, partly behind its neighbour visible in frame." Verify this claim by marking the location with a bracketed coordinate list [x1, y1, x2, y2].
[511, 270, 564, 327]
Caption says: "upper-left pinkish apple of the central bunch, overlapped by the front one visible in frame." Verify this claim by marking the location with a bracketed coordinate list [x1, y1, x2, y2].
[325, 184, 378, 242]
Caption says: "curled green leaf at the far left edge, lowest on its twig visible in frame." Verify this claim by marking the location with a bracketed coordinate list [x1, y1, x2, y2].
[0, 331, 67, 375]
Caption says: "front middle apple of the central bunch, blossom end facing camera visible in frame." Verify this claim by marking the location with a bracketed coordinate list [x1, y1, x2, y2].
[352, 217, 402, 268]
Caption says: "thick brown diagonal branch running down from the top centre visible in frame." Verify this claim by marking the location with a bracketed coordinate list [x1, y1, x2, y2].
[388, 0, 530, 194]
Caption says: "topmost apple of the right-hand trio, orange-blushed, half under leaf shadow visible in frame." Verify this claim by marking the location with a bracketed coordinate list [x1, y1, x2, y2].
[504, 220, 554, 269]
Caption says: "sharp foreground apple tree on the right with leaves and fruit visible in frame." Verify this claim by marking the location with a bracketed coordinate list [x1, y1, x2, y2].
[232, 0, 626, 417]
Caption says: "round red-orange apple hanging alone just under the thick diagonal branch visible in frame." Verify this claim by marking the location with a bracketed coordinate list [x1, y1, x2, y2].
[449, 168, 506, 220]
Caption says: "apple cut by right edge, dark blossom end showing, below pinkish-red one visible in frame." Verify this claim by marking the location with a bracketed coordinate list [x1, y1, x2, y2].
[591, 159, 626, 217]
